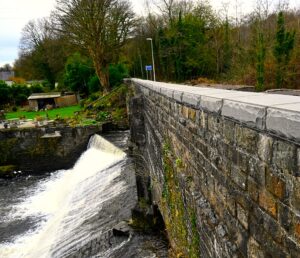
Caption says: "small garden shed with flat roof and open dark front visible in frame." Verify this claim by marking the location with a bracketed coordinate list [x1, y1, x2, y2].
[28, 92, 78, 110]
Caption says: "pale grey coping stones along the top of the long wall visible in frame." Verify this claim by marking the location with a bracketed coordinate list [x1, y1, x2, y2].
[131, 79, 300, 142]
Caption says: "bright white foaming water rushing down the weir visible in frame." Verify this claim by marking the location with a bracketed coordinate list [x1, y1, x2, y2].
[0, 135, 127, 258]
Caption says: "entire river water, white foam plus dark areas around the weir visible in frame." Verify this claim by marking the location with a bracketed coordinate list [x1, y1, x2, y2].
[0, 132, 167, 258]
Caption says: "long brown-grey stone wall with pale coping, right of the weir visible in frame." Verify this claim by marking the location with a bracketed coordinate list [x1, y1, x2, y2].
[127, 79, 300, 257]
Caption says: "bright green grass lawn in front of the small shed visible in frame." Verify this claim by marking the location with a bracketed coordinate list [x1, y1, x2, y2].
[5, 105, 81, 119]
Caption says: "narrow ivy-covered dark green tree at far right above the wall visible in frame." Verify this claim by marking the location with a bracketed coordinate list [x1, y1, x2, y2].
[274, 11, 296, 88]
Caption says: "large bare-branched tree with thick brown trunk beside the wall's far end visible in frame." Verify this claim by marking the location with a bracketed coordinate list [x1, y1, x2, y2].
[56, 0, 134, 94]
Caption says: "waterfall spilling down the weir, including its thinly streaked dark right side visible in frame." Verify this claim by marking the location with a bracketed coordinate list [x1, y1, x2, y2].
[0, 135, 136, 258]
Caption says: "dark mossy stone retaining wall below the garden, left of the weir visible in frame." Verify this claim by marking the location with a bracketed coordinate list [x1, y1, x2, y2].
[0, 126, 102, 174]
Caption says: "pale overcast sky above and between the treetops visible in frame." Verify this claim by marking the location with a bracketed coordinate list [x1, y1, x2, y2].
[0, 0, 300, 66]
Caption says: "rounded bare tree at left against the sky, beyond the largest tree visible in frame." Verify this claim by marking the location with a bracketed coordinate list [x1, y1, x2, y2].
[14, 18, 66, 87]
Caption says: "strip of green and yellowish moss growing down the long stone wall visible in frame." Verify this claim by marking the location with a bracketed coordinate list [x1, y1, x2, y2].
[160, 141, 200, 257]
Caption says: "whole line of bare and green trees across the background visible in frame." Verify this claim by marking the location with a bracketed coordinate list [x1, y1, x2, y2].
[14, 0, 300, 91]
